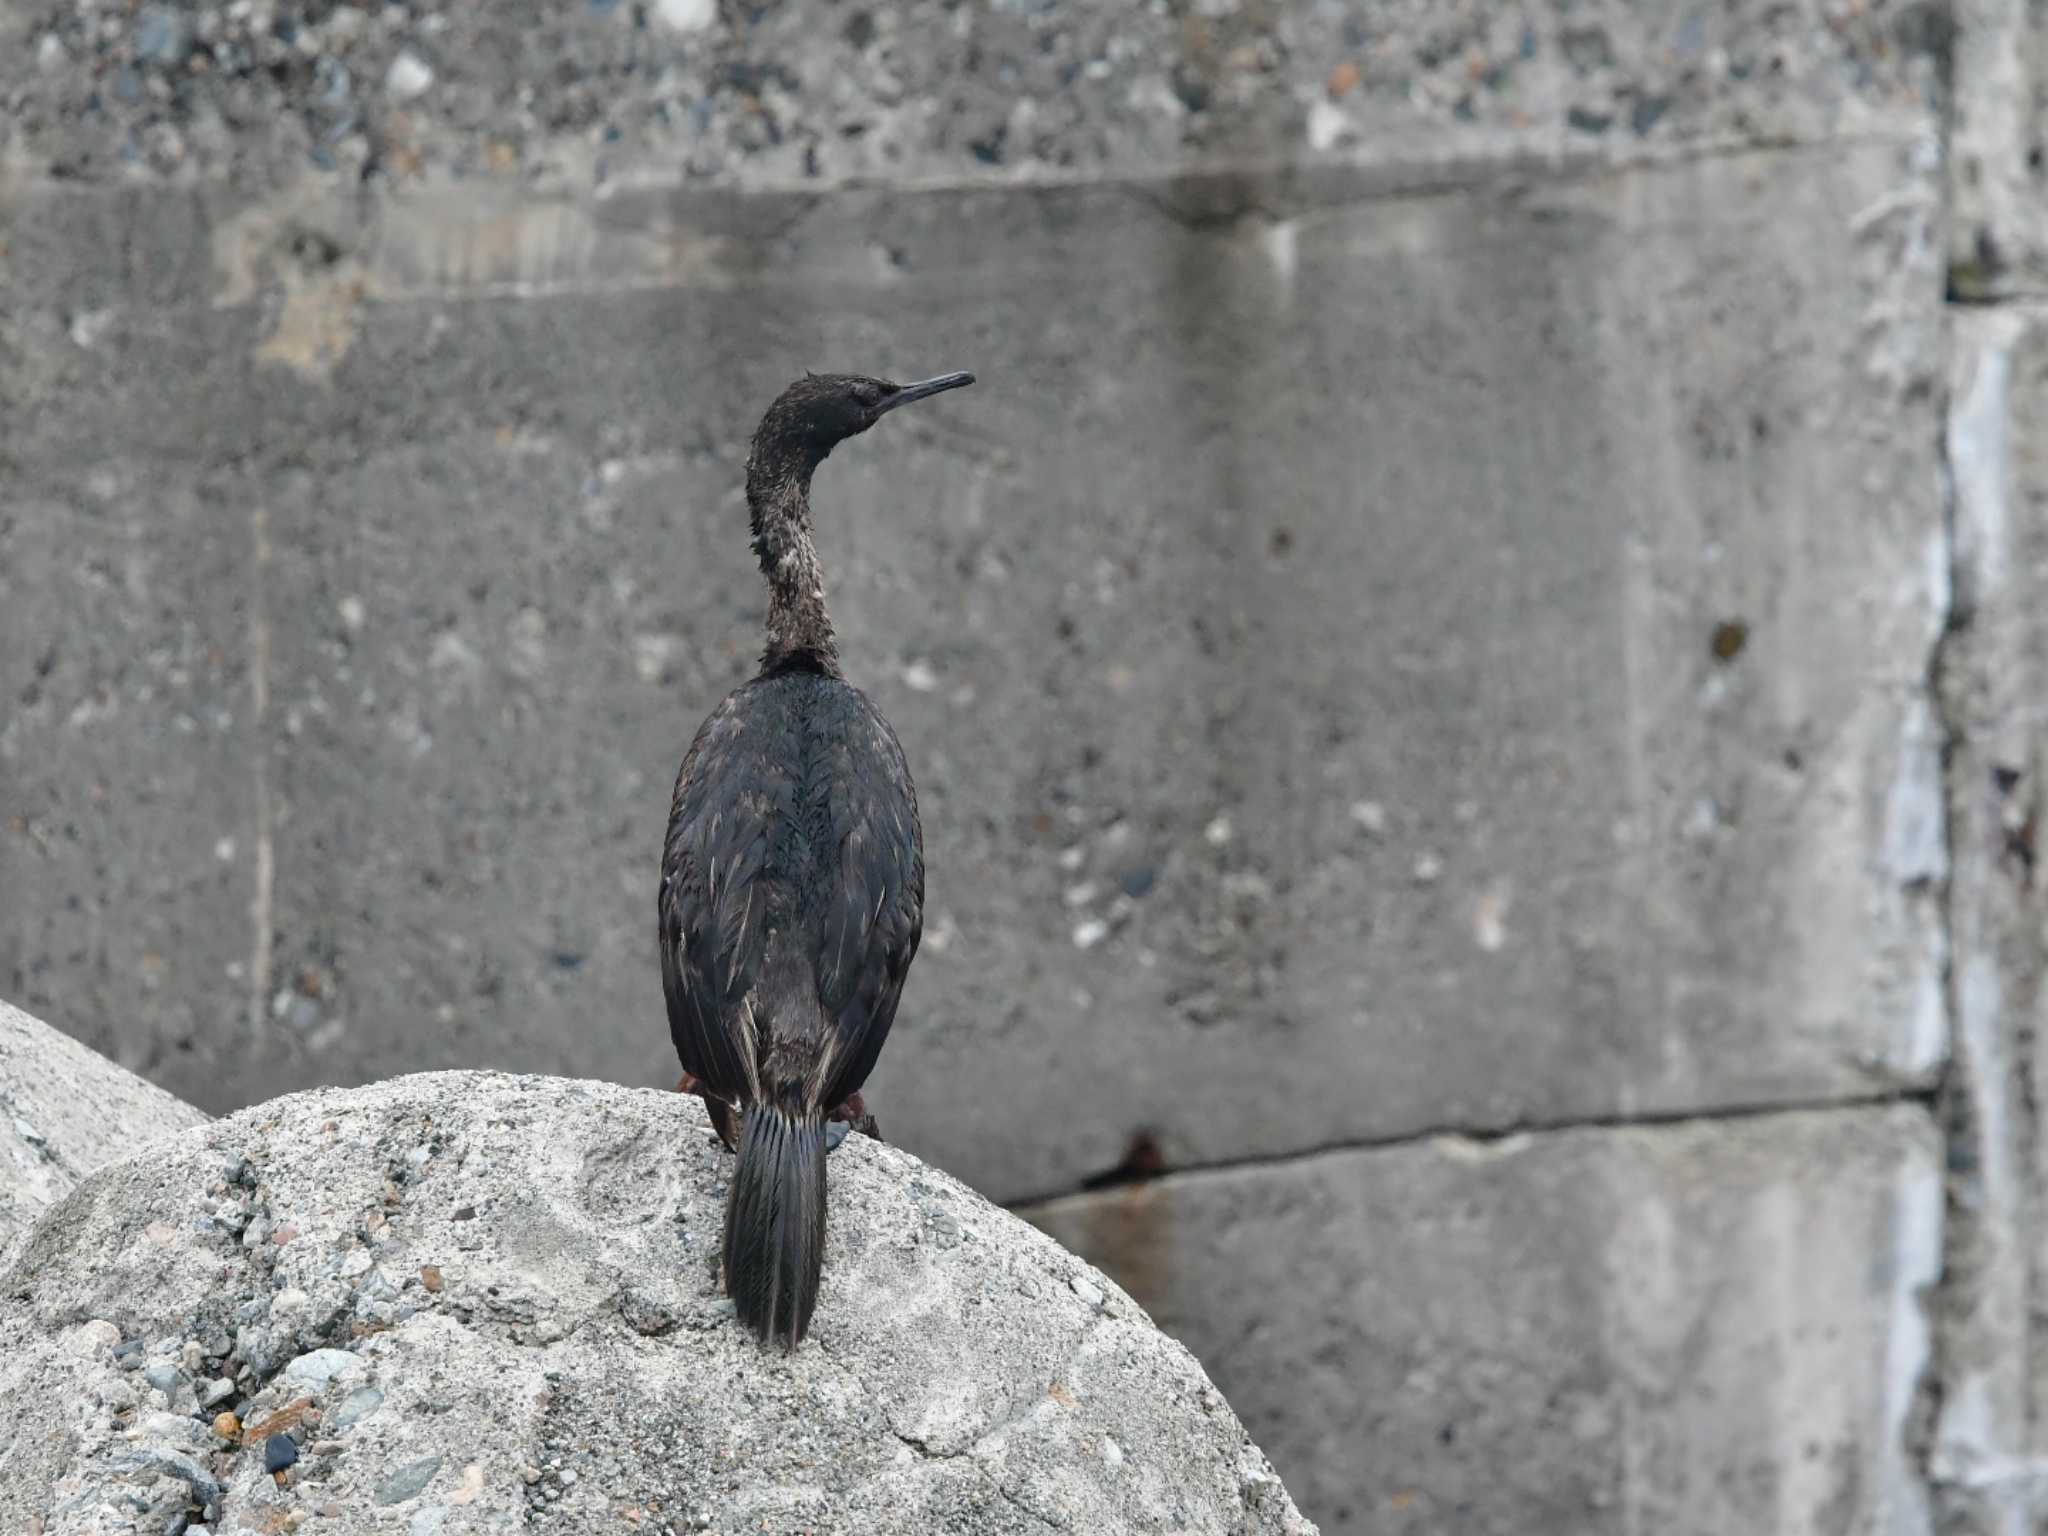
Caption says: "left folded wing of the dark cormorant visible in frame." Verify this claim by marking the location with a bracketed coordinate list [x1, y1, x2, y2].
[657, 690, 793, 1098]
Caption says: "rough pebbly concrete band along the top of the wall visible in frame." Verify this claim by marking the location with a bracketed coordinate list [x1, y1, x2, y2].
[0, 0, 1949, 188]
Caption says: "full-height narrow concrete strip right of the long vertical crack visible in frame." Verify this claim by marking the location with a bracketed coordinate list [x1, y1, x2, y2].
[1927, 0, 2048, 1536]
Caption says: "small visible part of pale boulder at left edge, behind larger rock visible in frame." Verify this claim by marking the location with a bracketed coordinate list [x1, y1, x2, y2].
[0, 1001, 207, 1262]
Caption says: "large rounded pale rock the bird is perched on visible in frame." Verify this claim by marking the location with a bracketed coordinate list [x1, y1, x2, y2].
[0, 1073, 1313, 1536]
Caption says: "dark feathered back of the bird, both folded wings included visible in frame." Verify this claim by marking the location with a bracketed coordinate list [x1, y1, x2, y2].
[659, 670, 924, 1108]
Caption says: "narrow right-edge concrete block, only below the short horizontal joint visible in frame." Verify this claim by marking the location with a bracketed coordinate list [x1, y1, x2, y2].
[1929, 305, 2048, 1536]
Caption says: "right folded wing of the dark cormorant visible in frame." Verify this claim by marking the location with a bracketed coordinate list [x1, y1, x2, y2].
[817, 696, 924, 1108]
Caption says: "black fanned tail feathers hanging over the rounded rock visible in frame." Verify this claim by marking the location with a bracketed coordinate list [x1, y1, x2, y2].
[725, 1104, 825, 1350]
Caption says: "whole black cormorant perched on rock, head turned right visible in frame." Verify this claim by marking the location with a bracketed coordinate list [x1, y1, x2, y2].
[657, 373, 975, 1350]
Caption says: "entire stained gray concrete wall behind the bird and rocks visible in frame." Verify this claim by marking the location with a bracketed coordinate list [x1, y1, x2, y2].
[0, 0, 2048, 1532]
